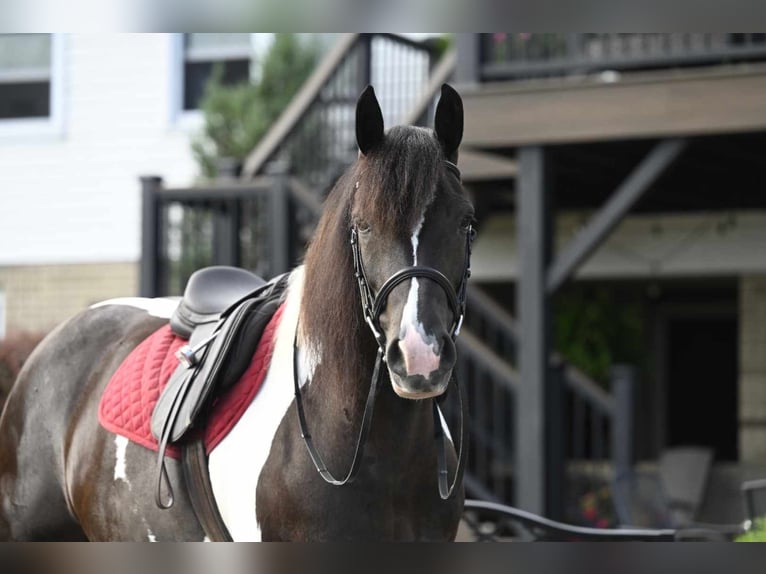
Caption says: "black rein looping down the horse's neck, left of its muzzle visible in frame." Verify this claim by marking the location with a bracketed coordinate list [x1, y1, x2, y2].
[293, 340, 383, 486]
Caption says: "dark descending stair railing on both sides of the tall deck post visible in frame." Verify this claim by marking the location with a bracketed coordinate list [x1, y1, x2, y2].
[453, 285, 634, 516]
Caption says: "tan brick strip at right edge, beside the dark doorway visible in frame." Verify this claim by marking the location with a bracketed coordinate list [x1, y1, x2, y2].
[739, 275, 766, 462]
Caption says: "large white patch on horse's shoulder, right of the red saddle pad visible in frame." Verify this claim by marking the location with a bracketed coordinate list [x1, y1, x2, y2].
[208, 267, 303, 542]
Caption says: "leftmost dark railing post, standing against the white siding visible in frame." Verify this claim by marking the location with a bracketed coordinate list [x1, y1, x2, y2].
[139, 175, 162, 297]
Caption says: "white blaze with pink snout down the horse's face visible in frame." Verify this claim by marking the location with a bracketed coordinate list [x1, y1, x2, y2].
[399, 214, 439, 377]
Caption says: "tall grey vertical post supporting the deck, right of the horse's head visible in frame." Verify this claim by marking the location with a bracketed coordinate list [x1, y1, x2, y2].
[515, 146, 552, 514]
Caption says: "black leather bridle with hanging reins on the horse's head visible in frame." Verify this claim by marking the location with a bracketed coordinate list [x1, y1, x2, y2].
[293, 161, 476, 500]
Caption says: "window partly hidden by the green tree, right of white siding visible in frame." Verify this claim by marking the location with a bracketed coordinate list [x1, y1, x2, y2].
[183, 33, 253, 110]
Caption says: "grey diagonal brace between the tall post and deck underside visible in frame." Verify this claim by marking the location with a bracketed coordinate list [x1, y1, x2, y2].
[545, 139, 687, 295]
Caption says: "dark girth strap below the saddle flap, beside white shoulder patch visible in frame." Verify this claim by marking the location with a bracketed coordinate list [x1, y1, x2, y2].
[181, 438, 233, 542]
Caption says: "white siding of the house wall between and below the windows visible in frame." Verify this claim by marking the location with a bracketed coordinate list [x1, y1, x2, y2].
[0, 34, 197, 266]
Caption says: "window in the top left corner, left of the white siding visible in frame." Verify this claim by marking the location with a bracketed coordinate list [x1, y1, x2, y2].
[0, 34, 53, 120]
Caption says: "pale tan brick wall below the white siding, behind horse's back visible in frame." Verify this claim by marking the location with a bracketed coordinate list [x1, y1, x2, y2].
[0, 263, 138, 333]
